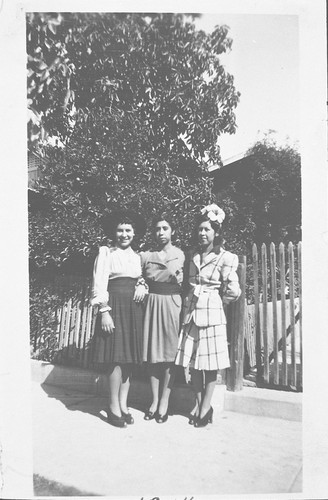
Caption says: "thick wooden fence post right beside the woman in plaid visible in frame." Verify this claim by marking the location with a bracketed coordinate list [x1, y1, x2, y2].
[227, 255, 246, 391]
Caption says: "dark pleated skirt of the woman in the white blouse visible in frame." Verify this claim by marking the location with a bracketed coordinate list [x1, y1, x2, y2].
[93, 278, 143, 364]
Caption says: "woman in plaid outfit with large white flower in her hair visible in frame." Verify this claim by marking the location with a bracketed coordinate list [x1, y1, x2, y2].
[175, 204, 241, 427]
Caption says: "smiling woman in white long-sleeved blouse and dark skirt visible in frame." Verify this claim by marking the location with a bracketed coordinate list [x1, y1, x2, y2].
[91, 211, 147, 427]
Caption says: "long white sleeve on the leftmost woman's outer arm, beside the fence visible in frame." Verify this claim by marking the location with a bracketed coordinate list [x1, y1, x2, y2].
[90, 246, 110, 306]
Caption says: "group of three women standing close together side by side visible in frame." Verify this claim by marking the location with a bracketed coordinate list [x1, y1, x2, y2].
[92, 204, 241, 427]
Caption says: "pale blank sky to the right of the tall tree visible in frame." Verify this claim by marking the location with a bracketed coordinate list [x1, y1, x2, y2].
[195, 13, 300, 161]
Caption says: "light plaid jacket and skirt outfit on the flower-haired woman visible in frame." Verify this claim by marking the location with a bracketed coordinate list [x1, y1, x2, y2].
[175, 247, 241, 370]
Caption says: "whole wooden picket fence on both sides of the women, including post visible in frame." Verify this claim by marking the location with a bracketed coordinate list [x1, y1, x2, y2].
[30, 243, 302, 390]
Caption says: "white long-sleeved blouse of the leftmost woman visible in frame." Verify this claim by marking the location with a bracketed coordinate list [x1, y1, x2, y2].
[90, 246, 141, 306]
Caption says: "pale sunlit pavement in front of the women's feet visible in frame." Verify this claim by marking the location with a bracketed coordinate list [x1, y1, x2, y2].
[32, 382, 302, 500]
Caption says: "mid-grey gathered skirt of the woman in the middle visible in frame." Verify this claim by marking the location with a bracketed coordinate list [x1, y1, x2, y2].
[143, 293, 182, 363]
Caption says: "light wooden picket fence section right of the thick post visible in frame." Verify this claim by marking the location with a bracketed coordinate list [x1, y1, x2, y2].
[250, 243, 303, 390]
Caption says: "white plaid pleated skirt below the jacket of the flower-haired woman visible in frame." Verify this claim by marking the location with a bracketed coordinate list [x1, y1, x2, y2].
[175, 321, 230, 370]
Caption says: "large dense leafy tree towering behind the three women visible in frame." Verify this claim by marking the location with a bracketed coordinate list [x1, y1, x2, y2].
[27, 14, 239, 266]
